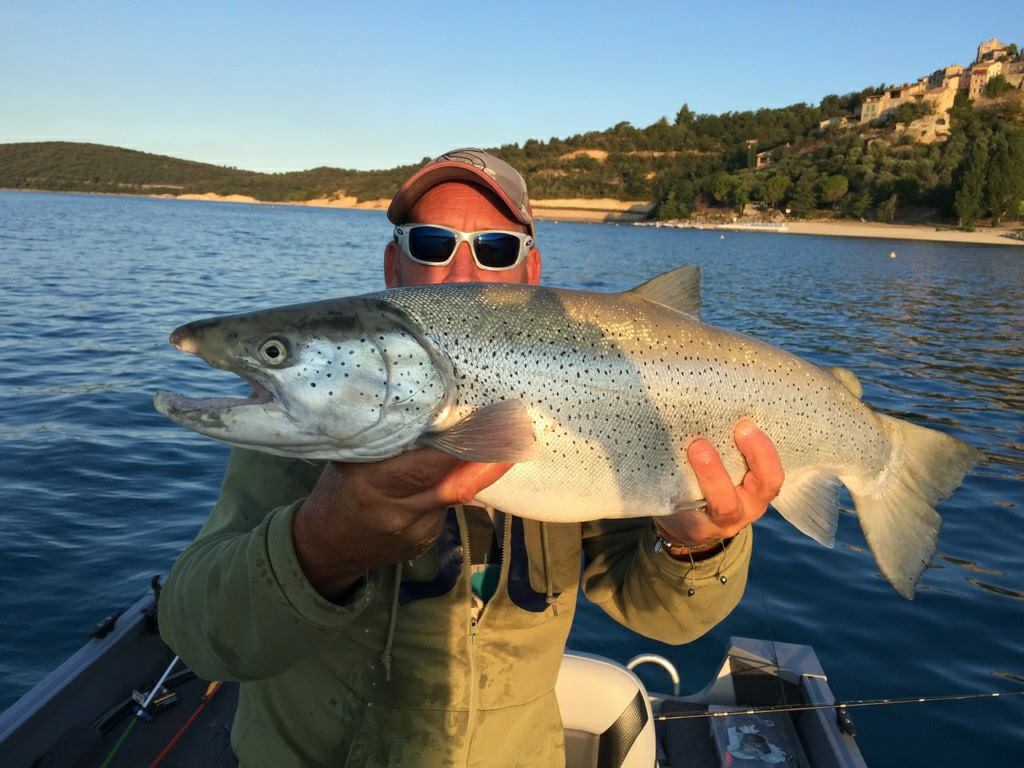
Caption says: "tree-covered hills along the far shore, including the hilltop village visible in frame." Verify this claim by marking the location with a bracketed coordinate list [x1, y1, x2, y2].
[0, 41, 1024, 227]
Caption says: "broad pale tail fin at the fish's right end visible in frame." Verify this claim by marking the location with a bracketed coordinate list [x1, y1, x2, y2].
[847, 414, 982, 600]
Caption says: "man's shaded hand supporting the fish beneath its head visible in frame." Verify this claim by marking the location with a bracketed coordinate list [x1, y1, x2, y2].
[292, 449, 512, 600]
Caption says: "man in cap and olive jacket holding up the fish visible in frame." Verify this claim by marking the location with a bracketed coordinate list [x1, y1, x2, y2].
[160, 150, 782, 767]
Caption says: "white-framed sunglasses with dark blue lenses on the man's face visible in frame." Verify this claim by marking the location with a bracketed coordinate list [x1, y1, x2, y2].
[394, 224, 534, 271]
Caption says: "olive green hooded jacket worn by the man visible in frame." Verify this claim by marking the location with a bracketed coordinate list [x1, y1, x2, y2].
[160, 450, 752, 768]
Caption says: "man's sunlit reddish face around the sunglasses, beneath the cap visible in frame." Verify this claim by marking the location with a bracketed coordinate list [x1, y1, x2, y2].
[384, 181, 541, 288]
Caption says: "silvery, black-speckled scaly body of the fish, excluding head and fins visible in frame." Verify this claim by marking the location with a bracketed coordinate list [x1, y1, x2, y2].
[378, 285, 887, 520]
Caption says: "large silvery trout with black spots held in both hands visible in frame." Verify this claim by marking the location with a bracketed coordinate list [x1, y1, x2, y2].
[155, 267, 978, 597]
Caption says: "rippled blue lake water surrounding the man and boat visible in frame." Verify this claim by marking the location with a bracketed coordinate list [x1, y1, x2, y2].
[0, 191, 1024, 766]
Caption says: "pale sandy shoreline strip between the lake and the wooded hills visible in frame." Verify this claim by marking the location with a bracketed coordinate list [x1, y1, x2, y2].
[5, 189, 1024, 246]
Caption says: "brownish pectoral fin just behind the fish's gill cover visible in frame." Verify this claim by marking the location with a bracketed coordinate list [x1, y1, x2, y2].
[419, 400, 537, 463]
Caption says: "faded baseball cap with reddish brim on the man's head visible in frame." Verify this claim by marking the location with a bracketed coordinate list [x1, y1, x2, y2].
[387, 147, 537, 238]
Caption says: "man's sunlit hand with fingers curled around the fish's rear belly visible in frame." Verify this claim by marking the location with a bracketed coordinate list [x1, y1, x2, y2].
[656, 419, 784, 547]
